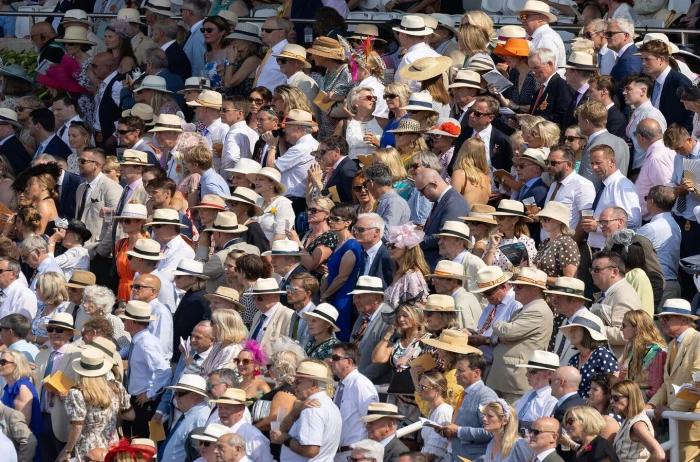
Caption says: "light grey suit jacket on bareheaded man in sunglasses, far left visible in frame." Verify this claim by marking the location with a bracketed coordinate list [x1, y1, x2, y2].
[75, 174, 122, 258]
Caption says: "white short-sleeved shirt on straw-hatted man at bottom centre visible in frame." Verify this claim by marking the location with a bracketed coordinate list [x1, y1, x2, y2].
[280, 390, 343, 462]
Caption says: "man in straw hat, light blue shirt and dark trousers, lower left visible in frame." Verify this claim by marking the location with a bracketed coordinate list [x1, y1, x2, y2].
[119, 300, 172, 437]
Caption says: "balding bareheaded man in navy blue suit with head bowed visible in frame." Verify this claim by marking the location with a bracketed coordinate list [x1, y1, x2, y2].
[415, 168, 470, 269]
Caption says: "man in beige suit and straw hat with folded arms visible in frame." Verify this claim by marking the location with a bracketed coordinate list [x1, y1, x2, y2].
[486, 267, 553, 403]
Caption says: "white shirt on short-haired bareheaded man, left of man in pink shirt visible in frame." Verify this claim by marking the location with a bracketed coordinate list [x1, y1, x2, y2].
[588, 170, 642, 249]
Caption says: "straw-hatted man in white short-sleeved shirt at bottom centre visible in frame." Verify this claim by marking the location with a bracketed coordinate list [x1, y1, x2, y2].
[270, 359, 343, 460]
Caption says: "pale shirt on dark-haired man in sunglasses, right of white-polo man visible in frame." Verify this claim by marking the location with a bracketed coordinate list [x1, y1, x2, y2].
[334, 369, 379, 446]
